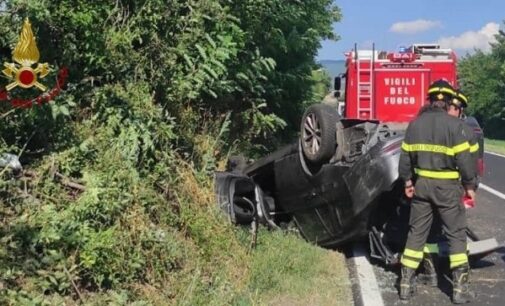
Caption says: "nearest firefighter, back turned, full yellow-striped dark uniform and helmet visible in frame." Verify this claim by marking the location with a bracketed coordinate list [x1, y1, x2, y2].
[399, 80, 476, 304]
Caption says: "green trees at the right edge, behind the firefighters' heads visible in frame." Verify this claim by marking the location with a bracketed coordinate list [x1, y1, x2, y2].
[458, 23, 505, 139]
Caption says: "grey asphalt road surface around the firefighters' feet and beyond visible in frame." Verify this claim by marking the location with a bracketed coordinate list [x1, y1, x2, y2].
[373, 154, 505, 306]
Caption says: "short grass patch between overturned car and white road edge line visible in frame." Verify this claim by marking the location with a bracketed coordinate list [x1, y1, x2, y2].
[246, 231, 352, 305]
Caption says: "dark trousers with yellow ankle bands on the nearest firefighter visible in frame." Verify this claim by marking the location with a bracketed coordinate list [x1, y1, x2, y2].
[401, 177, 468, 269]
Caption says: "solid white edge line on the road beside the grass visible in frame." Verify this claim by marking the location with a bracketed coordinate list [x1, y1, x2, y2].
[352, 244, 384, 306]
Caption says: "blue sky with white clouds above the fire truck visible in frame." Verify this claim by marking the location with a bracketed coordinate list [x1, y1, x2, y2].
[316, 0, 505, 60]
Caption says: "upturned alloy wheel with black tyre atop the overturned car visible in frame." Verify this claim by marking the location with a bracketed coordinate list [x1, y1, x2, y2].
[300, 104, 340, 165]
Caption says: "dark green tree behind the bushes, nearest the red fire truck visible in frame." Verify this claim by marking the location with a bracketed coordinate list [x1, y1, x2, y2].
[226, 0, 341, 143]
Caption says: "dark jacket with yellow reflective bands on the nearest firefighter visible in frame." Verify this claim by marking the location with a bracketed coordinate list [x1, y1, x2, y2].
[399, 108, 477, 189]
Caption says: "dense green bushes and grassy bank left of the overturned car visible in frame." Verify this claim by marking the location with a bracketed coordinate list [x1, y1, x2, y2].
[0, 0, 350, 305]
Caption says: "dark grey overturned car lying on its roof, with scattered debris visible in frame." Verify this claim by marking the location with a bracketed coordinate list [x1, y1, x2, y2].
[215, 104, 499, 265]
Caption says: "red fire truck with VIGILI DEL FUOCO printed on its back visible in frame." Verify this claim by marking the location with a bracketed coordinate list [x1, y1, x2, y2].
[335, 44, 457, 123]
